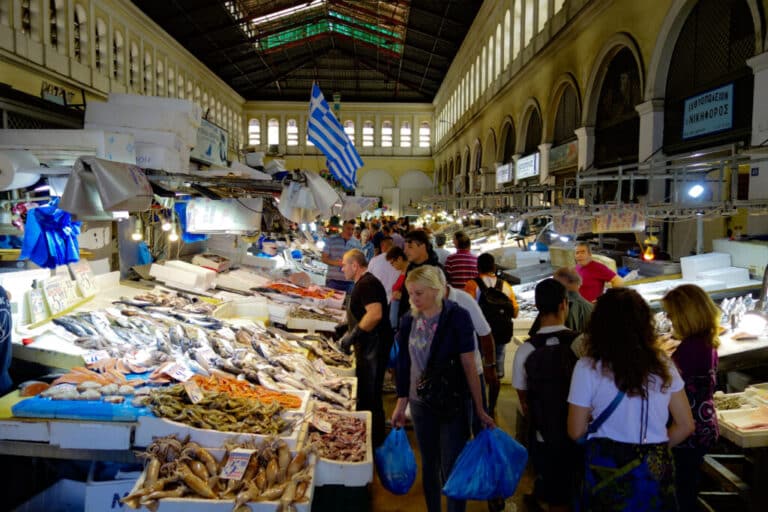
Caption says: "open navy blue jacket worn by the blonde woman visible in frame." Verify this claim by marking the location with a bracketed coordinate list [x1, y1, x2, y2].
[395, 300, 475, 397]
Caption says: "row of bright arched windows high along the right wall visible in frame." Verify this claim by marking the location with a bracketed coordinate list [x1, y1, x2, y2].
[436, 0, 565, 141]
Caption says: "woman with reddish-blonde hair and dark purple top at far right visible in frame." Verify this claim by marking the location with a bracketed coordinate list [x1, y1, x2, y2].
[661, 284, 721, 512]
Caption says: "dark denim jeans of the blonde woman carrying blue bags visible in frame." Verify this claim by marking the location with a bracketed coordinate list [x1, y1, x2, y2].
[410, 400, 469, 512]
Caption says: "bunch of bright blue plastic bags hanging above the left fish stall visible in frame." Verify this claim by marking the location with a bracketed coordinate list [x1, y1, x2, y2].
[19, 198, 80, 268]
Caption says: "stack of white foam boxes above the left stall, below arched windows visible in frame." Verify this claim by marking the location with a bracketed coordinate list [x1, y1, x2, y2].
[85, 93, 202, 173]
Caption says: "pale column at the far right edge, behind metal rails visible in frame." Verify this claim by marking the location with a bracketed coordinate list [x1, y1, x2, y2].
[747, 52, 768, 234]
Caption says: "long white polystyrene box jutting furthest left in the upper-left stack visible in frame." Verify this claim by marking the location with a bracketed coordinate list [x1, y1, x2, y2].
[85, 102, 197, 146]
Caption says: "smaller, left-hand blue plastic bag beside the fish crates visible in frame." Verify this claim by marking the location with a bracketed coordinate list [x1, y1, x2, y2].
[374, 428, 416, 494]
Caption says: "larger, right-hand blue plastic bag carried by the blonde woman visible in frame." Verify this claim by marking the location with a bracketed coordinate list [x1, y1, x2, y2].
[443, 428, 528, 501]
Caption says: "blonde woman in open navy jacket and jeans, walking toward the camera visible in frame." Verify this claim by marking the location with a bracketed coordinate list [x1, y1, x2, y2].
[392, 265, 495, 512]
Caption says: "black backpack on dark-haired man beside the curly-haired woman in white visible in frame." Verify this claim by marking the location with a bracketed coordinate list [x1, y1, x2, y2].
[525, 329, 578, 443]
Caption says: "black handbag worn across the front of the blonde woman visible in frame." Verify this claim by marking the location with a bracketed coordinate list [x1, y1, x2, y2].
[416, 314, 465, 419]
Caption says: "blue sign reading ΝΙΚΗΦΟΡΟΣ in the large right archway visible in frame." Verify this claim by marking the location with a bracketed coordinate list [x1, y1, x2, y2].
[683, 83, 733, 139]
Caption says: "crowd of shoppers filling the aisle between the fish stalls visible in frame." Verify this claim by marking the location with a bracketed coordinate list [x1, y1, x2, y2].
[323, 217, 720, 512]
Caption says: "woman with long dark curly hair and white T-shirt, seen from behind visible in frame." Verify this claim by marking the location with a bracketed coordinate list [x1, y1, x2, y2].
[568, 288, 694, 511]
